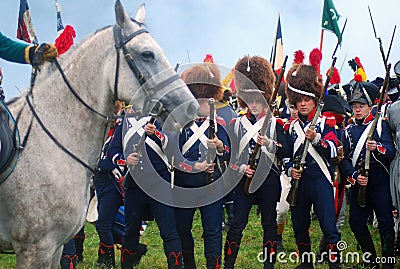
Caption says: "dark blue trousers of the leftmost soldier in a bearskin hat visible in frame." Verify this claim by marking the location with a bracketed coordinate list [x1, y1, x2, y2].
[175, 198, 225, 260]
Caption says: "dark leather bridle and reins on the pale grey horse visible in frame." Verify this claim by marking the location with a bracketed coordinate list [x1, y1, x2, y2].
[16, 20, 180, 173]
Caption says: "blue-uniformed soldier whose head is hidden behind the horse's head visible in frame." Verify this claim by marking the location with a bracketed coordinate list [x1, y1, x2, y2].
[108, 112, 183, 269]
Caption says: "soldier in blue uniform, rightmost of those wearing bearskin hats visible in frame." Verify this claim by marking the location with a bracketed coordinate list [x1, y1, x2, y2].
[285, 64, 340, 268]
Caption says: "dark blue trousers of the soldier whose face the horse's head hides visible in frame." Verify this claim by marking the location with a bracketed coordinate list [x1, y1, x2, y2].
[122, 185, 182, 255]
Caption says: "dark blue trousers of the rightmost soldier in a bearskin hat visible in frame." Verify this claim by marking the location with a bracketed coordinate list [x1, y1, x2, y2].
[290, 173, 339, 245]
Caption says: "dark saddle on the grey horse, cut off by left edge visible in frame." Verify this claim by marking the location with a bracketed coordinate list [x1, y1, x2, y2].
[0, 100, 18, 184]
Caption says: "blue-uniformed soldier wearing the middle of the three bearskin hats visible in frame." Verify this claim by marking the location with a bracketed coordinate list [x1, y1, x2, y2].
[224, 56, 289, 269]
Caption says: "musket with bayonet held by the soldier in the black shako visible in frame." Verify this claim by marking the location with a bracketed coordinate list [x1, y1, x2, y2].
[357, 6, 396, 207]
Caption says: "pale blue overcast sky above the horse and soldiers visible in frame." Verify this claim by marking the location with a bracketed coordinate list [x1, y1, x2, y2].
[0, 0, 400, 100]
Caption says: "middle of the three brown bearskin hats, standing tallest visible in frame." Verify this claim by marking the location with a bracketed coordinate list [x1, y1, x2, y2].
[234, 56, 275, 108]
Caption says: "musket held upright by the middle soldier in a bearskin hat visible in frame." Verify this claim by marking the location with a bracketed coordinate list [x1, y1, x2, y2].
[244, 55, 288, 195]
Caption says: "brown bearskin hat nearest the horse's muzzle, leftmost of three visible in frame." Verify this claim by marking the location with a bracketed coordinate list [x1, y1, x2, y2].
[182, 62, 223, 100]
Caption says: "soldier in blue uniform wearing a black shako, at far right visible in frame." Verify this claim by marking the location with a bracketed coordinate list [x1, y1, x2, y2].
[340, 81, 395, 268]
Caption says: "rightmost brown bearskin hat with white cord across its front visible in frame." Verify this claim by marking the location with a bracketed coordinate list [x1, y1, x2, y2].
[285, 64, 323, 105]
